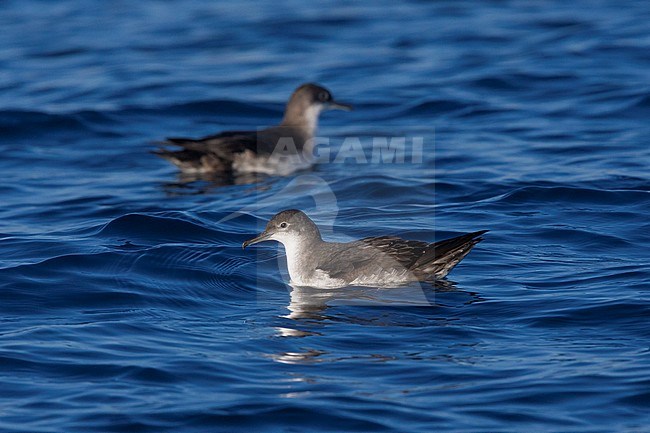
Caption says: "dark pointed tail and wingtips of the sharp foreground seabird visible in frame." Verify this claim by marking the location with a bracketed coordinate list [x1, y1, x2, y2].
[411, 230, 488, 280]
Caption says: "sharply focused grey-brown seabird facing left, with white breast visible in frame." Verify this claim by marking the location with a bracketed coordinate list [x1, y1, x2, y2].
[242, 209, 487, 287]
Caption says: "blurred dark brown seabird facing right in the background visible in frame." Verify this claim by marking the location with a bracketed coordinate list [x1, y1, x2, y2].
[153, 83, 352, 176]
